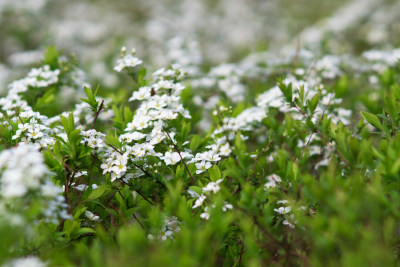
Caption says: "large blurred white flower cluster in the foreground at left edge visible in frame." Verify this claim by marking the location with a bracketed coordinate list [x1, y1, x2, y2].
[0, 145, 69, 223]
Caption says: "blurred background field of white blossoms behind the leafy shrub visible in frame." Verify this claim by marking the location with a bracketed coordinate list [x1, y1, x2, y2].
[0, 0, 400, 88]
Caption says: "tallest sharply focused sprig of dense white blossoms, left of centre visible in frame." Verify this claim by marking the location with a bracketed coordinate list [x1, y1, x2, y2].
[97, 49, 192, 180]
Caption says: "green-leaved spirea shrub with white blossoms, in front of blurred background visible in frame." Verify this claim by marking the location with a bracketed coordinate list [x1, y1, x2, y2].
[0, 44, 400, 266]
